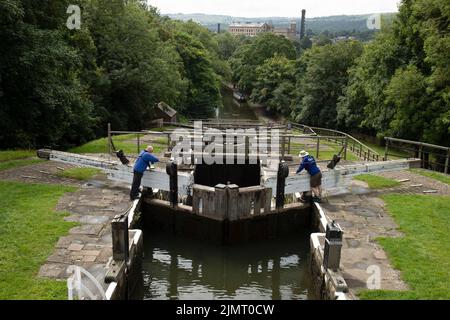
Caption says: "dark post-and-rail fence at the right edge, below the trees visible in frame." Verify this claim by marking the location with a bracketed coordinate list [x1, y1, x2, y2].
[384, 137, 450, 174]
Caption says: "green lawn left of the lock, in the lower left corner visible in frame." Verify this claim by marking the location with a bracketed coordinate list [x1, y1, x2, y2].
[0, 181, 76, 300]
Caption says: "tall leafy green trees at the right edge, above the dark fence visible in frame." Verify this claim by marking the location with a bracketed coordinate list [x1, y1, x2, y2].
[338, 0, 450, 145]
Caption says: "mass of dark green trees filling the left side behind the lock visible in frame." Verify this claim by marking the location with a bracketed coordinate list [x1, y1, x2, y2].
[0, 0, 225, 149]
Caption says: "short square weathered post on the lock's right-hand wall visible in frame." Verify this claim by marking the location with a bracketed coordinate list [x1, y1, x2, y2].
[323, 221, 343, 270]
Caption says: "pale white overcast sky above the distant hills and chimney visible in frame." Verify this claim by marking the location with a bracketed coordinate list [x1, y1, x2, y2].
[147, 0, 400, 18]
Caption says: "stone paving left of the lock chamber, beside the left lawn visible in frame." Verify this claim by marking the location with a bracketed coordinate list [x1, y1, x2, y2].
[39, 176, 130, 284]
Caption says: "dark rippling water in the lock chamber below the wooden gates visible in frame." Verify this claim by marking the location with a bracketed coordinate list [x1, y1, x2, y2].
[142, 231, 309, 300]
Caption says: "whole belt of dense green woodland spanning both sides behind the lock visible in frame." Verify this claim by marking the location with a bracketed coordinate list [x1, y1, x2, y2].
[0, 0, 450, 148]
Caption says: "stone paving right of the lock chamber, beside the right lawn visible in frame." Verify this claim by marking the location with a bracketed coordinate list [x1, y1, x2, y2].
[323, 171, 450, 298]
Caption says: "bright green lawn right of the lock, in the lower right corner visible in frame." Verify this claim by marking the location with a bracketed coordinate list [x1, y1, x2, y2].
[360, 194, 450, 300]
